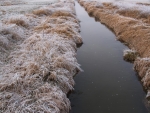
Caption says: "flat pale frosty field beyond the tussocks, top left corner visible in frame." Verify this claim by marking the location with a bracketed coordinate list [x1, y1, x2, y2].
[0, 0, 58, 19]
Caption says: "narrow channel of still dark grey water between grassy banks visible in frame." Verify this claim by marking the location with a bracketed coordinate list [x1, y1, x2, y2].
[69, 2, 148, 113]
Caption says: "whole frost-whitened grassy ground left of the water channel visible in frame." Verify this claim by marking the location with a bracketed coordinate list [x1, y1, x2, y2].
[0, 0, 82, 113]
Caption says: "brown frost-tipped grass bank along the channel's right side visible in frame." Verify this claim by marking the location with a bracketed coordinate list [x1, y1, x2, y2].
[79, 0, 150, 104]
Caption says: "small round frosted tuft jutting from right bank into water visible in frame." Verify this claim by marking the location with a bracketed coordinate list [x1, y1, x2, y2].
[123, 49, 138, 62]
